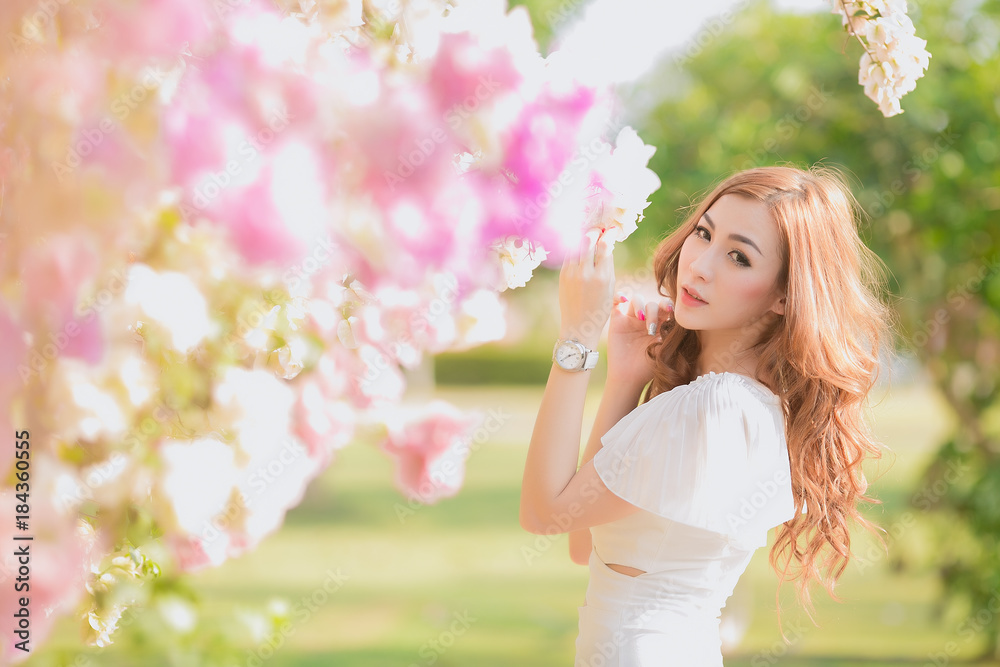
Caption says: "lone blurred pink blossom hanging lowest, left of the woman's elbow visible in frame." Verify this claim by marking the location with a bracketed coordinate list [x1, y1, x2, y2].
[382, 400, 480, 503]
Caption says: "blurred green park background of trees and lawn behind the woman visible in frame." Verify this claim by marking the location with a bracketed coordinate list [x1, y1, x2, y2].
[26, 0, 1000, 667]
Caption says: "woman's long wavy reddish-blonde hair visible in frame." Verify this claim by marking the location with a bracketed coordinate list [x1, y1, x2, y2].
[645, 166, 895, 616]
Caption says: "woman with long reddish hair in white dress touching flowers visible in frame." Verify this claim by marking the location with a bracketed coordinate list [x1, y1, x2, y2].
[520, 167, 890, 667]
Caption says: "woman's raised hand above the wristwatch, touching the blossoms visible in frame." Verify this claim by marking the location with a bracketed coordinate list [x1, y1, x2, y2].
[559, 229, 615, 349]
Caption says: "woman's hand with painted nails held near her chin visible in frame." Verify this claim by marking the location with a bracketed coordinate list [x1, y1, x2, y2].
[607, 297, 674, 391]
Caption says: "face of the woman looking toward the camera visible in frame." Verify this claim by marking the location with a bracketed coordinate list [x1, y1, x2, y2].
[674, 194, 785, 338]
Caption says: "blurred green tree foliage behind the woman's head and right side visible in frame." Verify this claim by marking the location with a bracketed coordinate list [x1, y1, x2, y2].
[630, 2, 1000, 656]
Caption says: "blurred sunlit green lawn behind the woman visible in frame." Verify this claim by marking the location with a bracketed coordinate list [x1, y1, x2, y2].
[29, 378, 986, 667]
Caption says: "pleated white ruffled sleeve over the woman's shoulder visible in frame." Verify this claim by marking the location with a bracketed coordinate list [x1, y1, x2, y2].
[594, 373, 795, 546]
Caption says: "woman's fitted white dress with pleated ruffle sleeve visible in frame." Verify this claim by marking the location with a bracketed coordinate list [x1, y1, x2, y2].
[575, 372, 795, 667]
